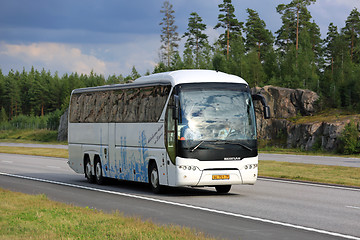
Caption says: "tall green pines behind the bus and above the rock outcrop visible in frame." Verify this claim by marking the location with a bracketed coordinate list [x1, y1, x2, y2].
[159, 0, 360, 111]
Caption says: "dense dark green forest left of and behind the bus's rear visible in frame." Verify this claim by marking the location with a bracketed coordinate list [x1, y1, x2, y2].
[0, 67, 140, 122]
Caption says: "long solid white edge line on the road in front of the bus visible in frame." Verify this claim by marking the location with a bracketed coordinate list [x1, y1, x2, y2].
[0, 172, 360, 240]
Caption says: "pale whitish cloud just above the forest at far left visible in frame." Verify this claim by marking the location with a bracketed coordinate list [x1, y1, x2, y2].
[0, 43, 106, 74]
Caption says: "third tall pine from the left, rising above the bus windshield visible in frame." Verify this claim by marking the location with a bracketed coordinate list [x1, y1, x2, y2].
[214, 0, 243, 60]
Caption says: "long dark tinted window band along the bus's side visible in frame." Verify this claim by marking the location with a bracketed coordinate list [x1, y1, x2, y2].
[70, 86, 170, 123]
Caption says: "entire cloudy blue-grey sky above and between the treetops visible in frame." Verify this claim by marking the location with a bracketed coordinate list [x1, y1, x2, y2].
[0, 0, 360, 77]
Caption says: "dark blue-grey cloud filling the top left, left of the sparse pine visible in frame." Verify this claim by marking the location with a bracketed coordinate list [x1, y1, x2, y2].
[0, 0, 160, 42]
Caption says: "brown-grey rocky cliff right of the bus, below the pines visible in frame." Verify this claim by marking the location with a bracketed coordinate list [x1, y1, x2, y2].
[252, 86, 359, 151]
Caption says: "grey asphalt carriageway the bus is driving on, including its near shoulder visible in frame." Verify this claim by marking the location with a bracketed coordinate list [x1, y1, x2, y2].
[0, 154, 360, 239]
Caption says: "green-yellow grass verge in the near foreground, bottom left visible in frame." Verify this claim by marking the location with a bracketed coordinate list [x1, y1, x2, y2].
[0, 188, 214, 240]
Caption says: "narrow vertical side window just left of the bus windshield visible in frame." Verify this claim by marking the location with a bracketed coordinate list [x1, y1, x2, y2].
[165, 94, 176, 164]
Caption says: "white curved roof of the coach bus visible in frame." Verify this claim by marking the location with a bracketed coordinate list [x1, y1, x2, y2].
[72, 69, 247, 93]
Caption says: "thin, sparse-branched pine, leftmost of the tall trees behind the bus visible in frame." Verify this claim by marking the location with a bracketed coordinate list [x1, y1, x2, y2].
[160, 1, 180, 68]
